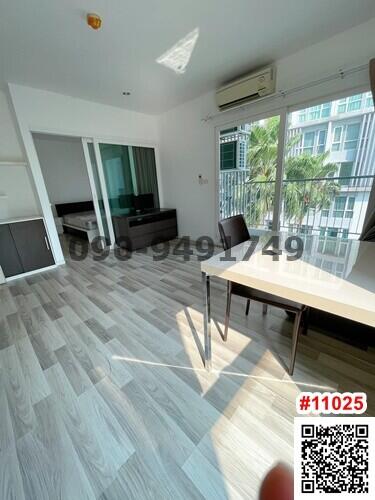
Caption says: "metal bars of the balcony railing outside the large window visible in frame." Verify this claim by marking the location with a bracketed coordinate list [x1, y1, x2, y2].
[220, 170, 375, 235]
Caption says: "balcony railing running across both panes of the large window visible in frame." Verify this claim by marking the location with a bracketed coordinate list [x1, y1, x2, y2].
[219, 170, 375, 238]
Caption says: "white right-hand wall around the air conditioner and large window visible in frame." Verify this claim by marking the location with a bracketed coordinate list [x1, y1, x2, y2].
[160, 19, 375, 240]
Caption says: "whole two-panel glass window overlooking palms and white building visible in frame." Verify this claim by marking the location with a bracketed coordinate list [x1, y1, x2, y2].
[219, 92, 375, 246]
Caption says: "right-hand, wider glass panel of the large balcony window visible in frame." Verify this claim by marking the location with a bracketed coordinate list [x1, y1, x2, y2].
[280, 93, 375, 244]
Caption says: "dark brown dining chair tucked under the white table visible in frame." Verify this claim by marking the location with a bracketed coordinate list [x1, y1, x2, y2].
[219, 214, 308, 375]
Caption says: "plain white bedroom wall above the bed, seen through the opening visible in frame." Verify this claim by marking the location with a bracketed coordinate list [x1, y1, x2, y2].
[33, 134, 92, 205]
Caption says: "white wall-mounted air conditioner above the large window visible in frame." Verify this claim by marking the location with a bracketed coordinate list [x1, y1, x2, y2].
[216, 66, 276, 111]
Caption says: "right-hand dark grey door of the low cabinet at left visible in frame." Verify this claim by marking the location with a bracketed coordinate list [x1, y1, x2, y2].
[9, 219, 55, 273]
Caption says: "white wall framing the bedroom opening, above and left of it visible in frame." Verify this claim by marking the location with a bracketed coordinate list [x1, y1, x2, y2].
[9, 84, 159, 264]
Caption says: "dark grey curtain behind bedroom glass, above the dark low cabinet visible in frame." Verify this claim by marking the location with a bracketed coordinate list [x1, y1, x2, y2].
[133, 146, 160, 208]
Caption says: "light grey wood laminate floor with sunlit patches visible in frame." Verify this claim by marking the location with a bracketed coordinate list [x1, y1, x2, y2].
[0, 237, 375, 500]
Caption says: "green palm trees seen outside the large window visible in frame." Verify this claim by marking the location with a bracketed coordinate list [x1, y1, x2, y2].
[247, 117, 340, 226]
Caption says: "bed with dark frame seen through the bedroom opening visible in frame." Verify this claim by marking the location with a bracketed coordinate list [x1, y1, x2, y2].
[55, 201, 99, 243]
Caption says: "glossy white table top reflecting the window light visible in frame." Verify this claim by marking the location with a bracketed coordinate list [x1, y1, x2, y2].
[201, 232, 375, 327]
